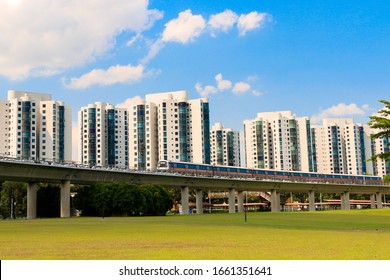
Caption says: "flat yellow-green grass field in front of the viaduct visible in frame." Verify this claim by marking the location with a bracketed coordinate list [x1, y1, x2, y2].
[0, 209, 390, 260]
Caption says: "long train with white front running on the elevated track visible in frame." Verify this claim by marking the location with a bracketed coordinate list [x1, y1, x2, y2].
[157, 160, 382, 185]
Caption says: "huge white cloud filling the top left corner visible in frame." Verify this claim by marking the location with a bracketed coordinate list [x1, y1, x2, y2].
[0, 0, 162, 80]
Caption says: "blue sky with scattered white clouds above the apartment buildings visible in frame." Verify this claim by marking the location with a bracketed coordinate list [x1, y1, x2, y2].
[0, 0, 390, 135]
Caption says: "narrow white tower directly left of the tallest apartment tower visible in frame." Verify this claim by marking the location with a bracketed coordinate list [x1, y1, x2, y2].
[128, 100, 158, 170]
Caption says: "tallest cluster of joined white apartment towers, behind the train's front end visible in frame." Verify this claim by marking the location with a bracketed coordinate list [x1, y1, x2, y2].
[79, 91, 210, 170]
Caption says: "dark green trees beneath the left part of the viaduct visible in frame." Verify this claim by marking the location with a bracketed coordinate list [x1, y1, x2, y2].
[0, 182, 173, 219]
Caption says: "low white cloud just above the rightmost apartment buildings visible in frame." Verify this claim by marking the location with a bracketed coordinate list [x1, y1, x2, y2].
[310, 103, 369, 123]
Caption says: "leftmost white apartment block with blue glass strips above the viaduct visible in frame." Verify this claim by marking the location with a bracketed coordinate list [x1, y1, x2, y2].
[1, 90, 72, 162]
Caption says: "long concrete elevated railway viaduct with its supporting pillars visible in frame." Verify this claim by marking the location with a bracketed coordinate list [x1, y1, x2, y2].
[0, 160, 390, 219]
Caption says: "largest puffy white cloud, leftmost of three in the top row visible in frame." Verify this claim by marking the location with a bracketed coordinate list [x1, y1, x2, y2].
[161, 10, 206, 44]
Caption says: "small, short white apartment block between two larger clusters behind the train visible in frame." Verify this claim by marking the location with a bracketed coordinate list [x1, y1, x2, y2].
[210, 123, 241, 166]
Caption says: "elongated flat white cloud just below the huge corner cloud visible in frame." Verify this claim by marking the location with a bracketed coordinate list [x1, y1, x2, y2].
[64, 64, 149, 89]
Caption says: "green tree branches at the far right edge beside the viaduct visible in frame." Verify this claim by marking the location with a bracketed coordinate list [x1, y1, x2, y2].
[368, 100, 390, 161]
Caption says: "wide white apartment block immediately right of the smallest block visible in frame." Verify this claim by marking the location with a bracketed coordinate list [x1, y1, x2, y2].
[244, 111, 315, 172]
